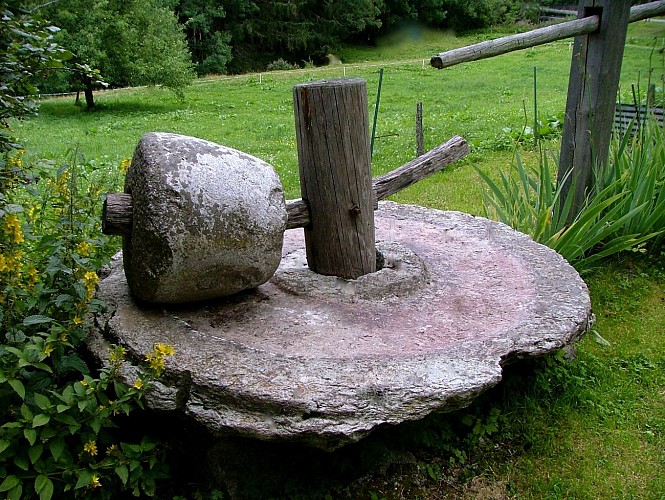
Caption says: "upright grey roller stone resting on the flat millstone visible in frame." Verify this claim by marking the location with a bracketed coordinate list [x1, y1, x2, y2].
[123, 133, 286, 303]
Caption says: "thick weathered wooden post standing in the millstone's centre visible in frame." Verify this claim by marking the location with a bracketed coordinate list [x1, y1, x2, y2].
[293, 78, 376, 279]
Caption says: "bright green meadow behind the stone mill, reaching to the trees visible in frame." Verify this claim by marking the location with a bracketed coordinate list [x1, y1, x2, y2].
[16, 23, 663, 213]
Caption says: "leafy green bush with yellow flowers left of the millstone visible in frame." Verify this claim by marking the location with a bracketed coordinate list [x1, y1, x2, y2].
[0, 151, 173, 499]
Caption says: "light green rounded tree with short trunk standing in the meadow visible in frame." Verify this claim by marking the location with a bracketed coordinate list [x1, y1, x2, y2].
[42, 0, 194, 107]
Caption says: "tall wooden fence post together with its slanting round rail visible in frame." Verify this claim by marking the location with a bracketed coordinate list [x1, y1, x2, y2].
[430, 0, 665, 216]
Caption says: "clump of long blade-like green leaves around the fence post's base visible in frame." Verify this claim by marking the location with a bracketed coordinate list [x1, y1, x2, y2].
[476, 114, 665, 271]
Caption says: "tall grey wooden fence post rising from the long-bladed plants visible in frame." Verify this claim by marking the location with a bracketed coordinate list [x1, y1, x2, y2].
[558, 0, 630, 217]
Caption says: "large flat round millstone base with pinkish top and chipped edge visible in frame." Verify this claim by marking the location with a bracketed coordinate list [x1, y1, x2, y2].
[90, 202, 593, 449]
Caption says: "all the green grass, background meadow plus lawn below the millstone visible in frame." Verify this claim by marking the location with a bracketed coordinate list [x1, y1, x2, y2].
[15, 17, 665, 499]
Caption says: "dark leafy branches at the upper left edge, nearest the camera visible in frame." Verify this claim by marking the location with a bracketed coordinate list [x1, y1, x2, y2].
[0, 1, 71, 153]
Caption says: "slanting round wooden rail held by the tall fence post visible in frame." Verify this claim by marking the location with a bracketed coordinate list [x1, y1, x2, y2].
[430, 0, 665, 69]
